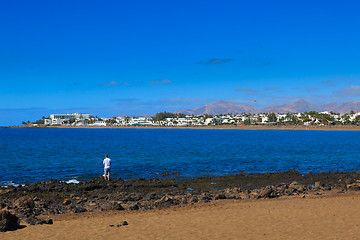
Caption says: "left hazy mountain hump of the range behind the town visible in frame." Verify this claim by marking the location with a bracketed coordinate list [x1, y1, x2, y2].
[175, 101, 260, 115]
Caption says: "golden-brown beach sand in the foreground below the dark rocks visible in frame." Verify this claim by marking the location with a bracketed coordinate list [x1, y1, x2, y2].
[0, 193, 360, 240]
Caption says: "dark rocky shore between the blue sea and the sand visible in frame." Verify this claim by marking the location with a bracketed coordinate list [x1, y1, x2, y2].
[0, 171, 360, 231]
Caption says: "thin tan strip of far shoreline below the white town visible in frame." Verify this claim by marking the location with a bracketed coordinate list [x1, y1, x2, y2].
[6, 125, 360, 131]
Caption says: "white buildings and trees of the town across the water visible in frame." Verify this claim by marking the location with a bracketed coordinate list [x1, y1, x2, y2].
[22, 111, 360, 127]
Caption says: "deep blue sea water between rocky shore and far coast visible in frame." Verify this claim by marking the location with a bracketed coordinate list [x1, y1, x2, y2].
[0, 128, 360, 185]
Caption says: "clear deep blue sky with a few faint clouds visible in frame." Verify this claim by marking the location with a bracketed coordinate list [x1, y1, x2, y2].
[0, 0, 360, 126]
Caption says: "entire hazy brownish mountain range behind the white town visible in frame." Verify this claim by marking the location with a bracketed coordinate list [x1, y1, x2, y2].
[175, 99, 360, 115]
